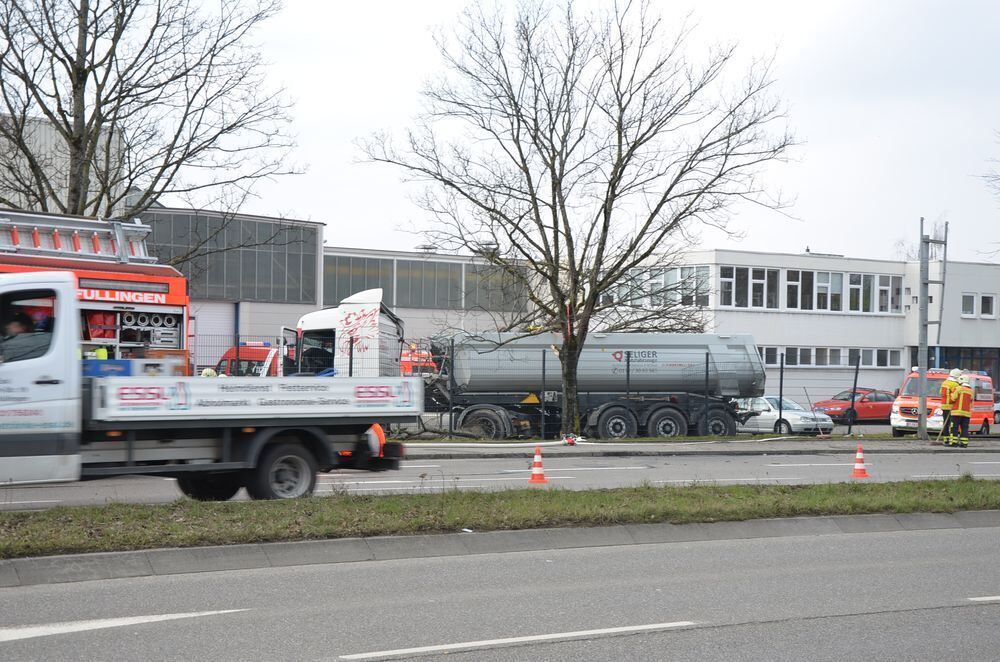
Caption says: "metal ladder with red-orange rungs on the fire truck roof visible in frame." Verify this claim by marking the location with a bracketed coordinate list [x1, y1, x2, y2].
[0, 210, 156, 264]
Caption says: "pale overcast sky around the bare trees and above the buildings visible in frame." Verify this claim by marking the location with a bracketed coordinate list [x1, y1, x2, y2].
[248, 0, 1000, 261]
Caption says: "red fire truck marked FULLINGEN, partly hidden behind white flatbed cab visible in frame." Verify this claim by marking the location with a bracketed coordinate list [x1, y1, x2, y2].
[0, 210, 188, 368]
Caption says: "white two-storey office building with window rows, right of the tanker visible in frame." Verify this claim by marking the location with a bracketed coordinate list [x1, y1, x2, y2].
[680, 250, 1000, 404]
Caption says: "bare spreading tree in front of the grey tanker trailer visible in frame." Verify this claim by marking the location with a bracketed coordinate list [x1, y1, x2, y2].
[364, 2, 792, 431]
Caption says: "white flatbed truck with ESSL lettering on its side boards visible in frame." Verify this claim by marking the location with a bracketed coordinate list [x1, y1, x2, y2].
[0, 271, 424, 501]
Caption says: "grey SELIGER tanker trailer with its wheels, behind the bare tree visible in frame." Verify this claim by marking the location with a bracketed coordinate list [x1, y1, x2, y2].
[426, 333, 764, 439]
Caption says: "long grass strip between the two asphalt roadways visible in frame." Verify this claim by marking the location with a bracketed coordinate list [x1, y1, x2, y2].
[0, 477, 1000, 558]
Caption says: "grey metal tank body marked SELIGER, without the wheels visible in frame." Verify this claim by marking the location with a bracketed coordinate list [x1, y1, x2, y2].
[454, 333, 764, 397]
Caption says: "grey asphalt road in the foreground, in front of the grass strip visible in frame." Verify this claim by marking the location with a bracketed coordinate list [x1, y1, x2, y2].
[0, 528, 1000, 662]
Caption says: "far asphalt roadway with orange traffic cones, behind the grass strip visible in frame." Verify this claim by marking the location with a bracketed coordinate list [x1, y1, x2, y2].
[0, 449, 1000, 510]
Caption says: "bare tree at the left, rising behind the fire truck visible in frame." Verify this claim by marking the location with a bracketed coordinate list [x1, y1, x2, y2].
[0, 0, 292, 223]
